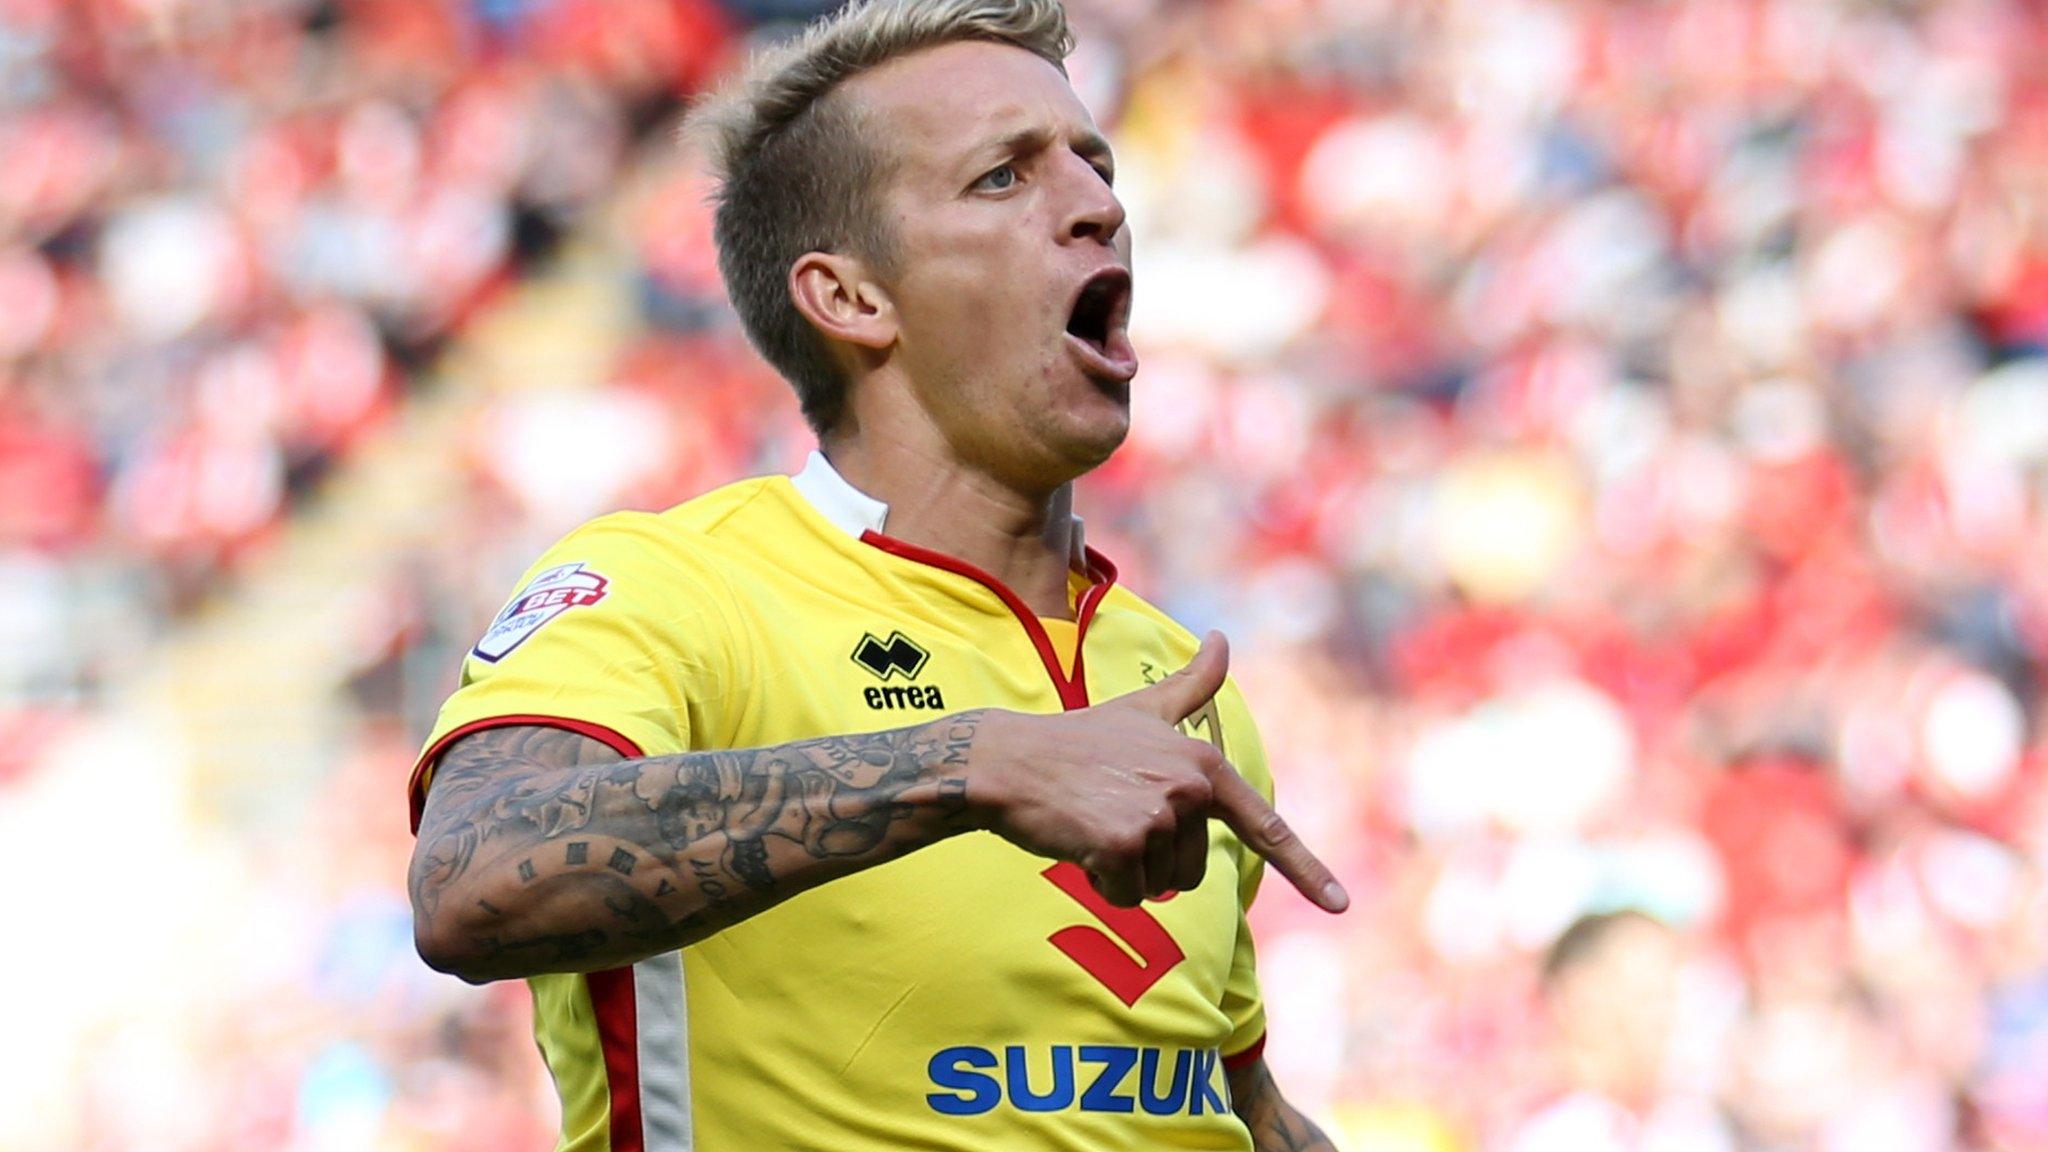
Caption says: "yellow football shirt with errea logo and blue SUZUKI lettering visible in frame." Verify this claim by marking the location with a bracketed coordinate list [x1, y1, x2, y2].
[412, 455, 1272, 1152]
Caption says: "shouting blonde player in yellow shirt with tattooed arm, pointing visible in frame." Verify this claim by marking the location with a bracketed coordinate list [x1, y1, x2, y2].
[412, 0, 1346, 1152]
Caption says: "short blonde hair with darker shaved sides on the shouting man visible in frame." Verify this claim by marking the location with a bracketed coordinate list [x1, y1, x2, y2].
[686, 0, 1073, 435]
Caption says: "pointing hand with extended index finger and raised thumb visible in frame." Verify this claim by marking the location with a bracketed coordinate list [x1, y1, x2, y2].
[967, 631, 1350, 912]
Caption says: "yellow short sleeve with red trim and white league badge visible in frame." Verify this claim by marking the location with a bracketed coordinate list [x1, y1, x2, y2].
[410, 512, 729, 828]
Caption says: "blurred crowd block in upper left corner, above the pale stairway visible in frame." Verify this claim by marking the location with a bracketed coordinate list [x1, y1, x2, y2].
[0, 0, 731, 746]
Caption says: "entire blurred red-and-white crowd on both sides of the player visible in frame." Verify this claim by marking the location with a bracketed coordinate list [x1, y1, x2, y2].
[12, 0, 2048, 1152]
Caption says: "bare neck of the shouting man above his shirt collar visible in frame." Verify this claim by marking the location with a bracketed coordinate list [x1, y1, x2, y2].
[823, 437, 1077, 619]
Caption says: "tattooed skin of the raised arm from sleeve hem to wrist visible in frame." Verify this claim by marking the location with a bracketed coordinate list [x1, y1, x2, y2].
[410, 711, 981, 982]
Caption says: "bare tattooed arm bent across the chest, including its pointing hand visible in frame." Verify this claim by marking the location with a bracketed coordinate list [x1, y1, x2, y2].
[410, 637, 1346, 982]
